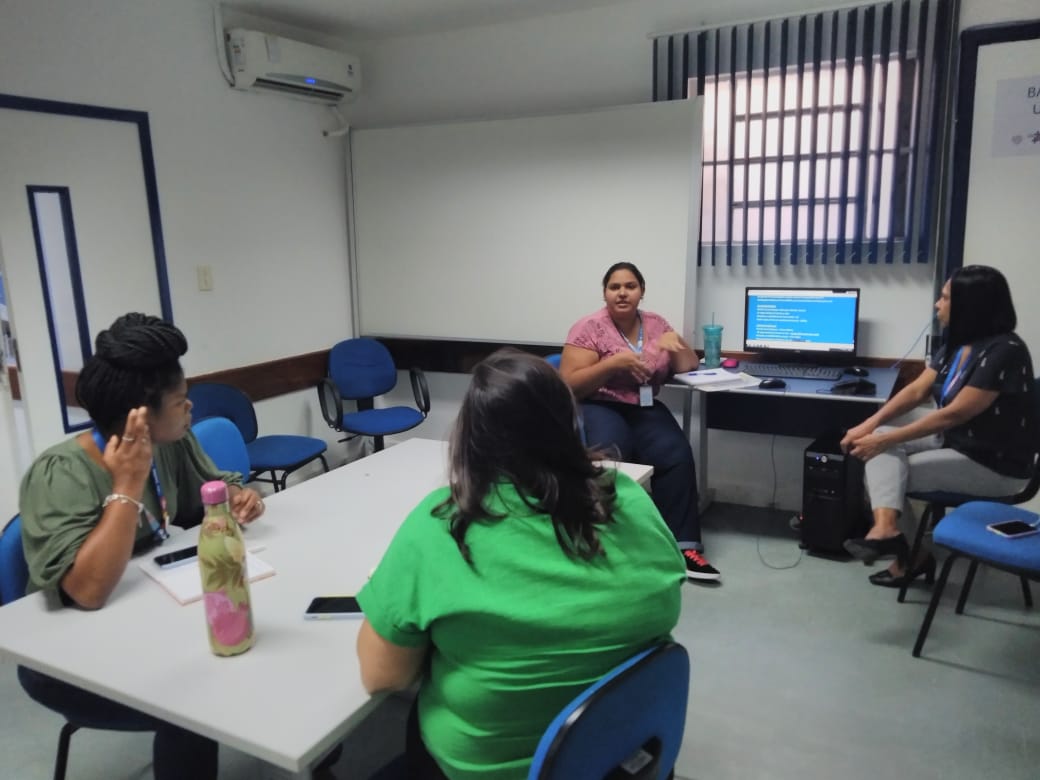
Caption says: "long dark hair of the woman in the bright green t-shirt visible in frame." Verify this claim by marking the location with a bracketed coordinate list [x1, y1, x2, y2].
[436, 348, 616, 564]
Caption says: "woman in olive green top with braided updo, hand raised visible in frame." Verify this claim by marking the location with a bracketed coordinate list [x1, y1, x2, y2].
[19, 314, 263, 780]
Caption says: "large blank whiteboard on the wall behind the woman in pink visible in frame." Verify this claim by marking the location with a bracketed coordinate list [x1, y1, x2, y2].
[350, 100, 701, 344]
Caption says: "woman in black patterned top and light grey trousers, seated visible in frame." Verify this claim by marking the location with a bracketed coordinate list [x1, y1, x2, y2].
[841, 265, 1040, 587]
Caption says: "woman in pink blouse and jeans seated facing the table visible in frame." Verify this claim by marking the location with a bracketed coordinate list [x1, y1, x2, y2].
[560, 262, 720, 580]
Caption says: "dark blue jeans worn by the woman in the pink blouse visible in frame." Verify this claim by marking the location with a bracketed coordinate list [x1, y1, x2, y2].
[581, 400, 701, 549]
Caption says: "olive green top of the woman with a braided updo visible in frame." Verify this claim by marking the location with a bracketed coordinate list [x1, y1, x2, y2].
[19, 431, 241, 593]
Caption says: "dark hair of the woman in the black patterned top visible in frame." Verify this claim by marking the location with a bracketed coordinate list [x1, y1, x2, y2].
[946, 265, 1018, 359]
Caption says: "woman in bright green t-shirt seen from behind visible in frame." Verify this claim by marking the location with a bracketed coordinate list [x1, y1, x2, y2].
[358, 349, 685, 780]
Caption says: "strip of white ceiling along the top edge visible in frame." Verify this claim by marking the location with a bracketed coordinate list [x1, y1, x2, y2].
[224, 0, 630, 38]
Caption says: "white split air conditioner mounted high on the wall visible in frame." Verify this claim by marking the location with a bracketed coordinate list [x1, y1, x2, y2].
[227, 27, 361, 105]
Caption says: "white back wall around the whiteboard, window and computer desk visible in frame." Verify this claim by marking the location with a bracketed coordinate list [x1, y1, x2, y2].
[349, 0, 1037, 509]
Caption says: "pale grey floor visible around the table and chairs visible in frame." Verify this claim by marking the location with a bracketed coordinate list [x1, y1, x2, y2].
[0, 504, 1040, 780]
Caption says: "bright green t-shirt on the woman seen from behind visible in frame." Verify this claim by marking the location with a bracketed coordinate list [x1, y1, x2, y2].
[358, 473, 685, 780]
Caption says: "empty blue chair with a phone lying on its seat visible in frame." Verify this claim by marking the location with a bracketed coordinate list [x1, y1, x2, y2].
[913, 501, 1040, 658]
